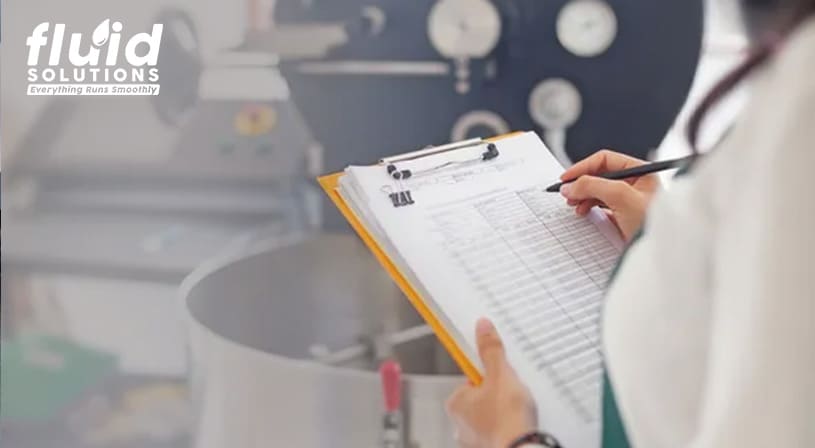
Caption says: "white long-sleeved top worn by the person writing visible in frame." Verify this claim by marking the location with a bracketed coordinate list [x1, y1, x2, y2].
[603, 20, 815, 448]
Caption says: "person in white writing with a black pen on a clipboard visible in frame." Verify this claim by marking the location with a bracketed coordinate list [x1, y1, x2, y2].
[447, 0, 815, 448]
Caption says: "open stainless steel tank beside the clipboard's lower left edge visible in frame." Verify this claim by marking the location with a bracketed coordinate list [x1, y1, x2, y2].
[182, 235, 462, 448]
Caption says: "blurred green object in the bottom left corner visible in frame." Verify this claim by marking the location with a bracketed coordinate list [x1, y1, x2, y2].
[0, 335, 117, 424]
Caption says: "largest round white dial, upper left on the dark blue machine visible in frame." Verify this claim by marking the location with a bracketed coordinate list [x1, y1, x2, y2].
[427, 0, 501, 59]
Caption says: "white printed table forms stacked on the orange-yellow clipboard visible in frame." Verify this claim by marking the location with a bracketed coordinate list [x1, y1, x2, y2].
[340, 133, 622, 447]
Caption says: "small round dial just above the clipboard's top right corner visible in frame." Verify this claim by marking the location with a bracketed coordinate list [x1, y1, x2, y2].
[529, 78, 583, 130]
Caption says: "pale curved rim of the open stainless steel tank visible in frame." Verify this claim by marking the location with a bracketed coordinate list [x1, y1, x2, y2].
[176, 233, 464, 384]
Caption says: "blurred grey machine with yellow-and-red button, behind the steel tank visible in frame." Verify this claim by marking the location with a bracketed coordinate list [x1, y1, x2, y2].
[3, 9, 319, 284]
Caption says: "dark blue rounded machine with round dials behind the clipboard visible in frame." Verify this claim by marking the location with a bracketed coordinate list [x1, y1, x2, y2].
[274, 0, 703, 170]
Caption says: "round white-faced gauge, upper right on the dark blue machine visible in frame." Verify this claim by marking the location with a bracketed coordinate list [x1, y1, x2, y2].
[557, 0, 617, 58]
